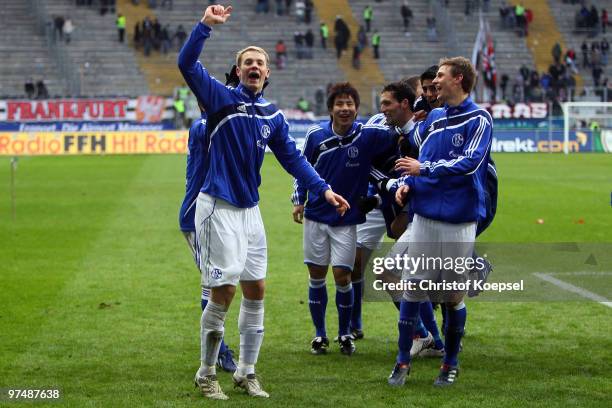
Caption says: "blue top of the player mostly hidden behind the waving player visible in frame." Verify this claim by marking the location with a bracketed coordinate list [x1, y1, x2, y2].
[179, 117, 208, 232]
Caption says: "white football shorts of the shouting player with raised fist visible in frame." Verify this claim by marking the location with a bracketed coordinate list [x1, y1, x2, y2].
[195, 193, 268, 288]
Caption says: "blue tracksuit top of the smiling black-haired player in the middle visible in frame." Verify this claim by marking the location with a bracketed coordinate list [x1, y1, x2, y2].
[292, 121, 397, 227]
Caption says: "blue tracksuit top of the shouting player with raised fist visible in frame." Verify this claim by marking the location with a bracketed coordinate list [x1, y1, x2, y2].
[178, 22, 329, 208]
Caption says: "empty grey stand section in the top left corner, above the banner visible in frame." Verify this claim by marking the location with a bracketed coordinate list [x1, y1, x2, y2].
[0, 0, 67, 98]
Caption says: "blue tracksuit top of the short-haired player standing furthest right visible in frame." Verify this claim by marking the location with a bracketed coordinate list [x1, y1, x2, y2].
[398, 97, 493, 224]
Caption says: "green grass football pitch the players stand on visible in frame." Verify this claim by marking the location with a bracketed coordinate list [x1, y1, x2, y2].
[0, 154, 612, 408]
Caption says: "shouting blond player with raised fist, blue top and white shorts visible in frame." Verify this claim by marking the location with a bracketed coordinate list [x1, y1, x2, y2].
[178, 5, 349, 399]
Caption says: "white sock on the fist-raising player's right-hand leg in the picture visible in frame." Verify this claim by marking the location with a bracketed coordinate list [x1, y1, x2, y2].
[237, 298, 264, 377]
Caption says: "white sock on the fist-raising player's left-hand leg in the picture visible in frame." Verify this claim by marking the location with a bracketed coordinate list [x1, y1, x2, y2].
[198, 300, 227, 377]
